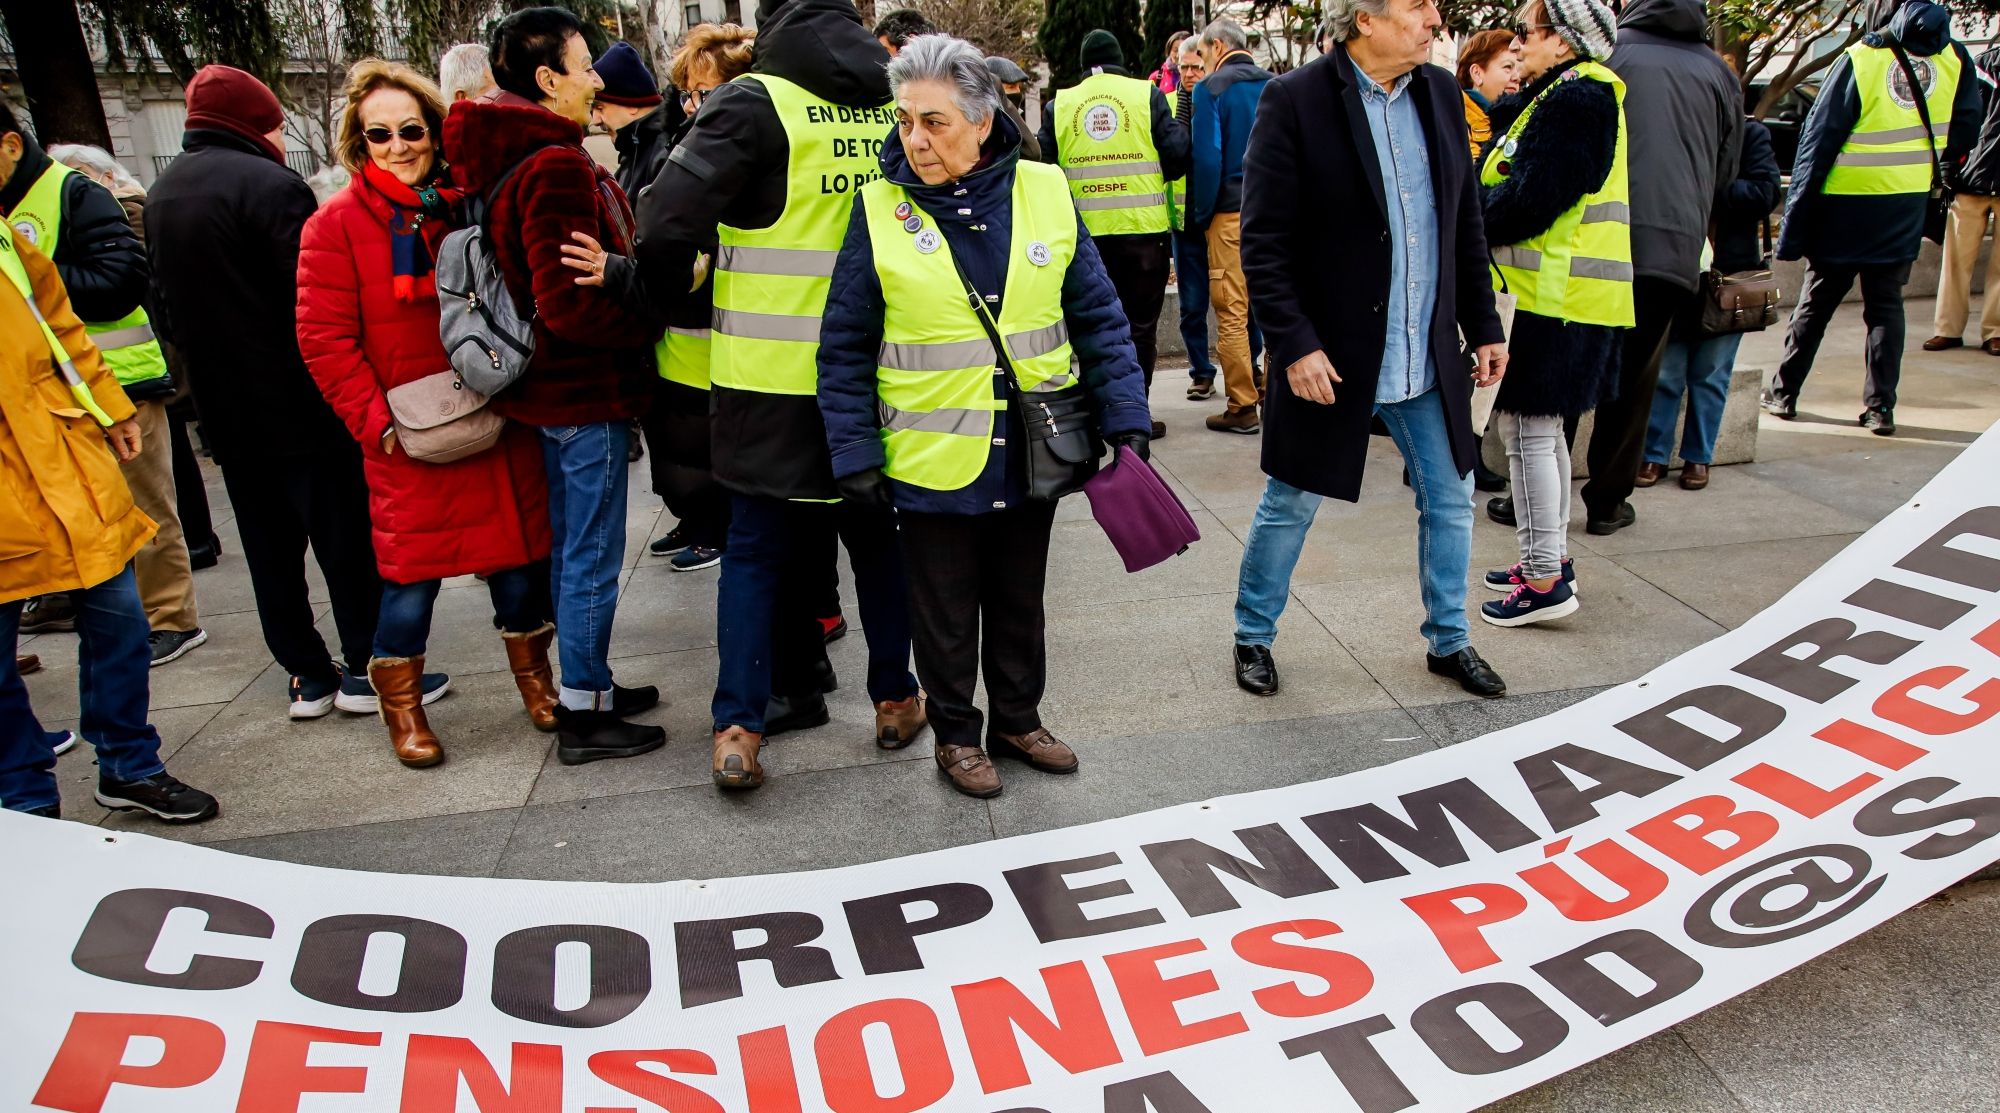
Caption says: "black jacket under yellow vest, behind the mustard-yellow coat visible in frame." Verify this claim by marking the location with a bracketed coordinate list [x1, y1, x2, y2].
[0, 132, 148, 324]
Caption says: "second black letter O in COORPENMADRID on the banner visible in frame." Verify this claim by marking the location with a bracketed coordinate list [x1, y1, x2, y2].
[492, 923, 652, 1029]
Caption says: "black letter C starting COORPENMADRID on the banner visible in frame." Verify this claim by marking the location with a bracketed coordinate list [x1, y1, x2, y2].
[70, 889, 276, 989]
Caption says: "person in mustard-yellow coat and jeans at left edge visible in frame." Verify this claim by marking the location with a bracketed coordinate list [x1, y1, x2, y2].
[0, 224, 216, 823]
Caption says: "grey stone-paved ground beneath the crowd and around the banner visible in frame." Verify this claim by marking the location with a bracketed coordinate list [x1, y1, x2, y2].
[22, 300, 2000, 1113]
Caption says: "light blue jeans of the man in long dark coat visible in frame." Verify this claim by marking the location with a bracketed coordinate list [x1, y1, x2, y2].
[1236, 388, 1472, 657]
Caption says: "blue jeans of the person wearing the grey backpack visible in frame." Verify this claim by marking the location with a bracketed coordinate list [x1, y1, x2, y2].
[540, 420, 632, 711]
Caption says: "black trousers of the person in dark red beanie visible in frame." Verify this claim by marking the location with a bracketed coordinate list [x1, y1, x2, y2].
[222, 444, 382, 681]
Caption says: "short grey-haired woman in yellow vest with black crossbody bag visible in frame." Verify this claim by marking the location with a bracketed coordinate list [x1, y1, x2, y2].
[818, 36, 1152, 797]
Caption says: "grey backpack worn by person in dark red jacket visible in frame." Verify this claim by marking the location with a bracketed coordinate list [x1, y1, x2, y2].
[432, 154, 534, 394]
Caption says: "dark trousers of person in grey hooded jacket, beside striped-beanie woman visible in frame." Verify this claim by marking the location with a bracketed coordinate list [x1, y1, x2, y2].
[1584, 278, 1694, 518]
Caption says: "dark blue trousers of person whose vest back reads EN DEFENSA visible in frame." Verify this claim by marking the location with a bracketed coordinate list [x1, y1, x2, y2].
[710, 494, 916, 733]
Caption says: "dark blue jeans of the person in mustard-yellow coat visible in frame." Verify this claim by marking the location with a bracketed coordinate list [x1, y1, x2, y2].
[0, 565, 166, 811]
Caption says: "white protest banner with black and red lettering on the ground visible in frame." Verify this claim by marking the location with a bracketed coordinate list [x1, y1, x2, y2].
[11, 434, 2000, 1113]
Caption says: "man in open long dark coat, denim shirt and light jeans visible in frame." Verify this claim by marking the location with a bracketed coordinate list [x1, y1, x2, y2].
[1236, 0, 1506, 697]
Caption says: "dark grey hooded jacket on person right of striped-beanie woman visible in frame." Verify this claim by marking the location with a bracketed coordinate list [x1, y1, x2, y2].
[1608, 0, 1744, 290]
